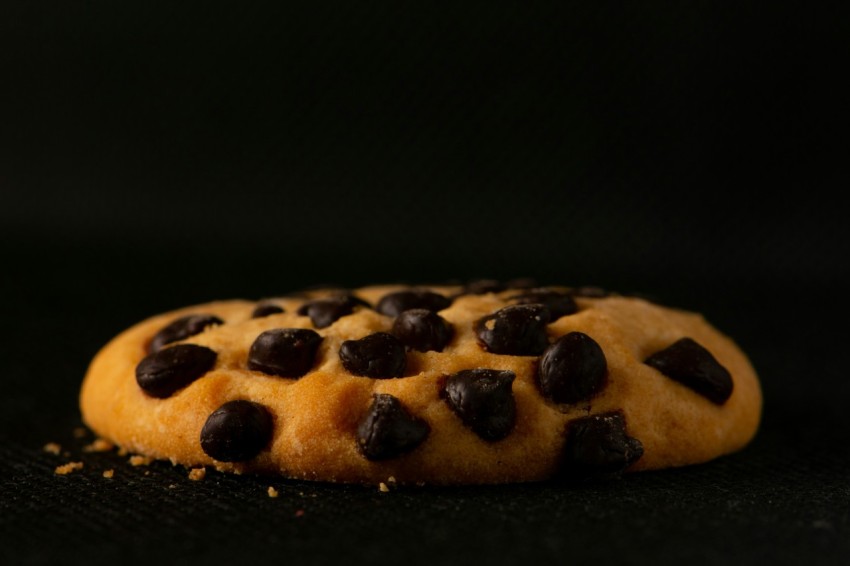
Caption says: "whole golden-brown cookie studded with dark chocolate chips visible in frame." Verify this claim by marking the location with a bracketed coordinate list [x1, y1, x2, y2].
[80, 281, 762, 485]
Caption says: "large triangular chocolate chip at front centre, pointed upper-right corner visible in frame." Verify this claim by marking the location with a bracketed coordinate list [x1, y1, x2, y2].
[440, 368, 516, 441]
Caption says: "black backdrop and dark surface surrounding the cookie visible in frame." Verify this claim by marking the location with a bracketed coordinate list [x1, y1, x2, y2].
[0, 1, 850, 564]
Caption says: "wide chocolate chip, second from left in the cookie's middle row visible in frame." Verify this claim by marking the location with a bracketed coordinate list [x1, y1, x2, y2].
[248, 328, 322, 378]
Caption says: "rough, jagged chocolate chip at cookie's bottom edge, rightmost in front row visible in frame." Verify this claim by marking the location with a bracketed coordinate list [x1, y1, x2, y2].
[561, 411, 643, 478]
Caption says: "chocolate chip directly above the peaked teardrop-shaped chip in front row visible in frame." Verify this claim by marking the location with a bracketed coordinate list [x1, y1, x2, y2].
[339, 332, 407, 379]
